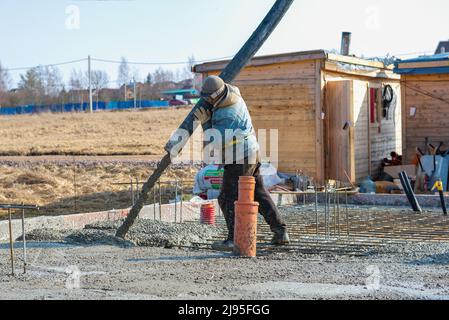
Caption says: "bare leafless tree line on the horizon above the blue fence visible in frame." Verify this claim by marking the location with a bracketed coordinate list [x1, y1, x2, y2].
[0, 56, 195, 107]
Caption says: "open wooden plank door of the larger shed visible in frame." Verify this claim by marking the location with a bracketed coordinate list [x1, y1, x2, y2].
[325, 80, 356, 182]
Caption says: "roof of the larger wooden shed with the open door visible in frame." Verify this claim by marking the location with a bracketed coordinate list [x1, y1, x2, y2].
[193, 50, 390, 73]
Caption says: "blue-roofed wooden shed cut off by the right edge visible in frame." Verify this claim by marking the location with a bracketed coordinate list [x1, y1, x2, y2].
[394, 53, 449, 161]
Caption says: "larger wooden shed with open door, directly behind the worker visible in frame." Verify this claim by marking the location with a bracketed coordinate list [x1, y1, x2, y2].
[194, 50, 402, 183]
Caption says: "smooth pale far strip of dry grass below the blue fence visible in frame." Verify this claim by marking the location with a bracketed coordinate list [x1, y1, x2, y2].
[0, 108, 190, 156]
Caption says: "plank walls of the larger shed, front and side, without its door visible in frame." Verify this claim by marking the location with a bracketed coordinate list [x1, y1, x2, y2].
[198, 59, 402, 182]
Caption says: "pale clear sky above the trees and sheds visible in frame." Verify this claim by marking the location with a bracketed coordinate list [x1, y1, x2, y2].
[0, 0, 449, 87]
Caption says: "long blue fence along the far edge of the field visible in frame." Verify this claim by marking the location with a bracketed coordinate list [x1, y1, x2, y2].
[0, 100, 169, 115]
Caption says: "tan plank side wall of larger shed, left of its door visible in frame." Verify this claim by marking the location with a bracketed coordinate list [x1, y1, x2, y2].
[206, 60, 321, 177]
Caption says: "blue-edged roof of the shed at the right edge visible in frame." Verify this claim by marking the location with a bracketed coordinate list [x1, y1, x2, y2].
[394, 53, 449, 75]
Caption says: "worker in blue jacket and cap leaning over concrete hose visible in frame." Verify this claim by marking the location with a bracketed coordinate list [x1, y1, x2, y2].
[195, 76, 290, 251]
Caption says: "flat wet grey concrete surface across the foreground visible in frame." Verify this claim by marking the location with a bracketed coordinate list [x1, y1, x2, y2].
[0, 244, 449, 300]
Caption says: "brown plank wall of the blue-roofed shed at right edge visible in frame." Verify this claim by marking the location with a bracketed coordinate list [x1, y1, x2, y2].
[402, 74, 449, 161]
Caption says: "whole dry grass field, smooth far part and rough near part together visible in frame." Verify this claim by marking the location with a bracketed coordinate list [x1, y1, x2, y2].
[0, 108, 200, 218]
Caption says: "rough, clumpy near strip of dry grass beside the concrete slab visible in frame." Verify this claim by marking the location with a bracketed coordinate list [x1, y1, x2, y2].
[0, 163, 196, 219]
